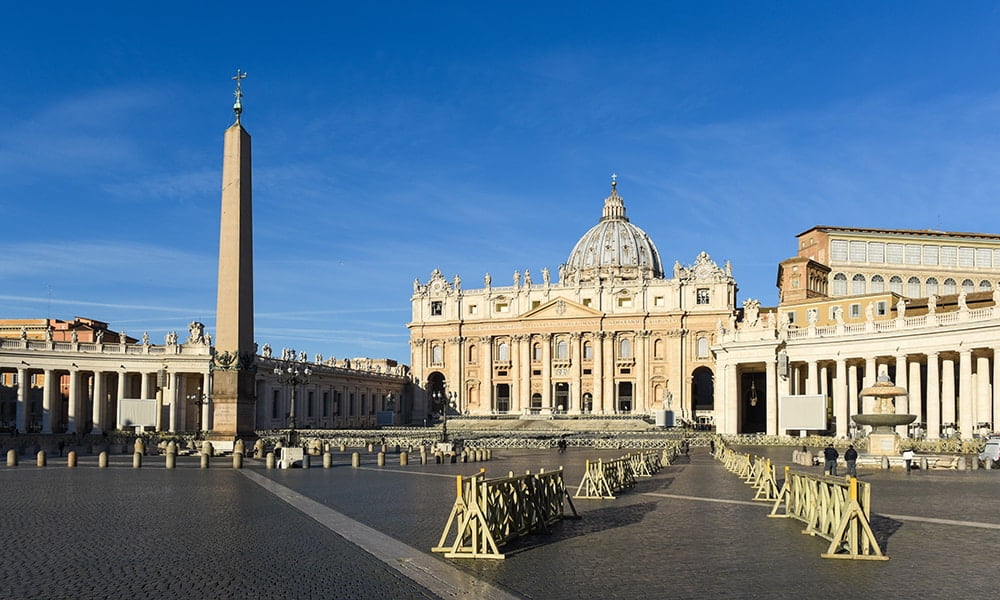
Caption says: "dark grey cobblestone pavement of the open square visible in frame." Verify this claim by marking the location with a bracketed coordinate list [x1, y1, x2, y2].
[0, 448, 1000, 600]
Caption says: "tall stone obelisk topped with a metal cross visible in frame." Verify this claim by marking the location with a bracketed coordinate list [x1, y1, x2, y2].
[209, 71, 257, 440]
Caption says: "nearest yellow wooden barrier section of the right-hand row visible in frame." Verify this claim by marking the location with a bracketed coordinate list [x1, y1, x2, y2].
[768, 467, 889, 560]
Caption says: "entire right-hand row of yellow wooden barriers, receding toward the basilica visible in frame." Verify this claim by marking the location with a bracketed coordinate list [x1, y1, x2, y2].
[715, 443, 889, 560]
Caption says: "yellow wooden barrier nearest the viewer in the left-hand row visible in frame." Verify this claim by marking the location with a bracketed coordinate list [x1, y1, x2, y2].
[431, 468, 579, 559]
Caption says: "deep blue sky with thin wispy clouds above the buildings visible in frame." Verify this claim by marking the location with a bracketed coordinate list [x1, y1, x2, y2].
[0, 2, 1000, 362]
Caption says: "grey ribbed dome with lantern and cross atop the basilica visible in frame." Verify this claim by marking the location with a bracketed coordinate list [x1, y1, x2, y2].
[560, 177, 663, 281]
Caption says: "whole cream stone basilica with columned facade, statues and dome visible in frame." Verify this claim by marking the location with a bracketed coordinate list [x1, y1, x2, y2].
[408, 182, 737, 421]
